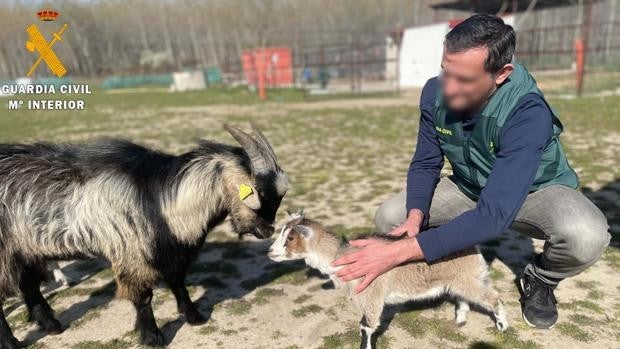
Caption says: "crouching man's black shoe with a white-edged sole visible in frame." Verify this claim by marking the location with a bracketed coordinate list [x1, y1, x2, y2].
[521, 274, 558, 329]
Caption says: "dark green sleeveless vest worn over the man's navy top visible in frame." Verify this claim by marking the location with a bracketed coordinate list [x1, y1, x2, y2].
[435, 64, 579, 200]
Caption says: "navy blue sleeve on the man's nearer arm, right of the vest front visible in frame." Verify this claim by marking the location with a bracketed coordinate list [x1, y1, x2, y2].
[418, 94, 553, 262]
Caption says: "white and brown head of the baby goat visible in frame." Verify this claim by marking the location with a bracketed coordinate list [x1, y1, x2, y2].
[267, 211, 320, 262]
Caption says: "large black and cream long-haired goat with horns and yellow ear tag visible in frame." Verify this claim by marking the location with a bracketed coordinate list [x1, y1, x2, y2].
[0, 126, 288, 349]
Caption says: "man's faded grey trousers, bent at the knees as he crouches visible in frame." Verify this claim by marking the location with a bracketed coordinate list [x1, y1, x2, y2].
[375, 177, 611, 285]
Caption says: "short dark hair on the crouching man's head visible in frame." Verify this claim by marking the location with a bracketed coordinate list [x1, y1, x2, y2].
[444, 15, 517, 74]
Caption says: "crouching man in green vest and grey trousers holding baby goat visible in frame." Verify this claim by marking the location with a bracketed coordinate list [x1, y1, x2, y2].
[334, 15, 610, 328]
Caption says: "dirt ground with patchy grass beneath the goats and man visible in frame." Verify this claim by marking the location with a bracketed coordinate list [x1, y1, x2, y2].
[5, 91, 620, 349]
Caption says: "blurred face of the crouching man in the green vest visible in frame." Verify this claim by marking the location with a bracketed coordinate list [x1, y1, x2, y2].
[440, 48, 496, 112]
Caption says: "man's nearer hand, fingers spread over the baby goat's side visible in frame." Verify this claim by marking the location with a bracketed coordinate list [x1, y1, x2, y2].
[332, 238, 424, 293]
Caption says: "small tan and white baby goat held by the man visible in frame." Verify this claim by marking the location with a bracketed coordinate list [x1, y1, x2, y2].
[269, 212, 508, 349]
